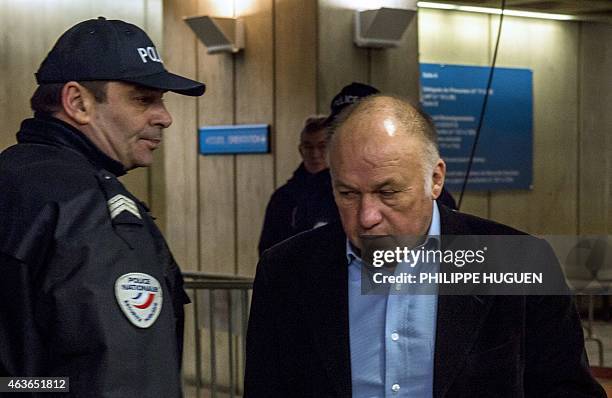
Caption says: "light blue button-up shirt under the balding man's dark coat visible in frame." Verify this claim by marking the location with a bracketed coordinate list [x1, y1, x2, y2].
[346, 201, 440, 398]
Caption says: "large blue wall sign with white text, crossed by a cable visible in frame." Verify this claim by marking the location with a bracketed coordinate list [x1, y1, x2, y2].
[421, 64, 533, 191]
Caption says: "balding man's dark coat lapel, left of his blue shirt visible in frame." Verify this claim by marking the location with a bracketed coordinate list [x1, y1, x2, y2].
[304, 224, 351, 397]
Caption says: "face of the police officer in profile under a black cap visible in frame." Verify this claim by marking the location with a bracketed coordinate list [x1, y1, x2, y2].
[89, 82, 172, 170]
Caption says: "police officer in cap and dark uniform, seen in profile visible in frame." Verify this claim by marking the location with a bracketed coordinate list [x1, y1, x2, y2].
[0, 17, 205, 397]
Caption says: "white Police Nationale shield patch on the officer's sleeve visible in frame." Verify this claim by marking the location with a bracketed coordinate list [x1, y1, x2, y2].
[115, 272, 163, 328]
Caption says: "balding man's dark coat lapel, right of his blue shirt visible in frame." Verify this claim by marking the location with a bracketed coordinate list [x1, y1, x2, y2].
[433, 206, 492, 398]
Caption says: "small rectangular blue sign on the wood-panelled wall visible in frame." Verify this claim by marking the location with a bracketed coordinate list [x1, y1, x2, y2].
[198, 124, 270, 155]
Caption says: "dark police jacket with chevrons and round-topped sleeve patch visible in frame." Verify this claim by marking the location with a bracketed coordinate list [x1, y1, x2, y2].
[0, 116, 188, 397]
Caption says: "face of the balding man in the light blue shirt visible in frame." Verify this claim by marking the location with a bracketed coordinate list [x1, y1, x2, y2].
[330, 110, 444, 248]
